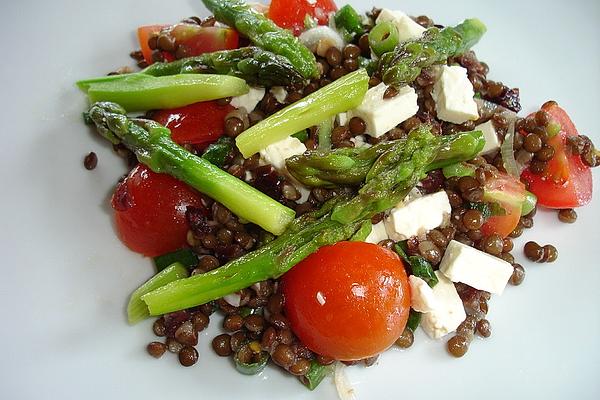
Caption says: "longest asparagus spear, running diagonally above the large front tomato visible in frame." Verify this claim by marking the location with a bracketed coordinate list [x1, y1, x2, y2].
[142, 126, 439, 315]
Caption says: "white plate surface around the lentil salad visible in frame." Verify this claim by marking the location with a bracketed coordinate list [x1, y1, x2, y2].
[0, 0, 600, 400]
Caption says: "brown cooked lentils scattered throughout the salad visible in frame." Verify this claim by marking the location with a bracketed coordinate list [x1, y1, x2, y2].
[84, 9, 599, 381]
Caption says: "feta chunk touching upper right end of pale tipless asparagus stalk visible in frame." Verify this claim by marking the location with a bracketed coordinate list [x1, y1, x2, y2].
[348, 82, 419, 137]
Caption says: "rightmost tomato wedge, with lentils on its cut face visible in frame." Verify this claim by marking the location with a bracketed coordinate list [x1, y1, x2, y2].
[521, 103, 593, 208]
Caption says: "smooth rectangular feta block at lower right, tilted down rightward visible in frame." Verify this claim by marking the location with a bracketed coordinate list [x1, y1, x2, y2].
[440, 240, 513, 294]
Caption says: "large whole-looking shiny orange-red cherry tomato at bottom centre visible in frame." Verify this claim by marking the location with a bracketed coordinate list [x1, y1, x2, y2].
[282, 242, 410, 361]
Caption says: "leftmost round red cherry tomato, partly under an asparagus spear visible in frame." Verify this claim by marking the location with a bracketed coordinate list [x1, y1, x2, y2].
[112, 164, 204, 257]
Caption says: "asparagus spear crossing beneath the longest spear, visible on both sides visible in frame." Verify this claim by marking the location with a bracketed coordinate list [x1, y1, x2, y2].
[286, 131, 485, 187]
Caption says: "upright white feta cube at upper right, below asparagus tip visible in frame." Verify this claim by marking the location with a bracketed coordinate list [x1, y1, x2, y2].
[431, 65, 479, 124]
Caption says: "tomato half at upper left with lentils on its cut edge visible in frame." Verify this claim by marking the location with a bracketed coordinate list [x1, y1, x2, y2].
[138, 23, 239, 64]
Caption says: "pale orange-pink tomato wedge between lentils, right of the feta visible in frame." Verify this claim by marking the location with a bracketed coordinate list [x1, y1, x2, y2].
[481, 173, 525, 237]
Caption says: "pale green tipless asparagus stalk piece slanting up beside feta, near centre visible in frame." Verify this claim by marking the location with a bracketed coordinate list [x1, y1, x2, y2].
[235, 69, 369, 158]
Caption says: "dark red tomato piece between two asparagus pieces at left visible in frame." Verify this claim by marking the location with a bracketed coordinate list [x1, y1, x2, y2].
[152, 101, 235, 147]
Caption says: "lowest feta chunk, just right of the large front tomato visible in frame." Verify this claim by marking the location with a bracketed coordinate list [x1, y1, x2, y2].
[421, 271, 467, 339]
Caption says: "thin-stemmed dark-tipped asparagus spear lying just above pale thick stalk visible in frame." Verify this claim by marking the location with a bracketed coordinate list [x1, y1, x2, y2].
[77, 47, 304, 91]
